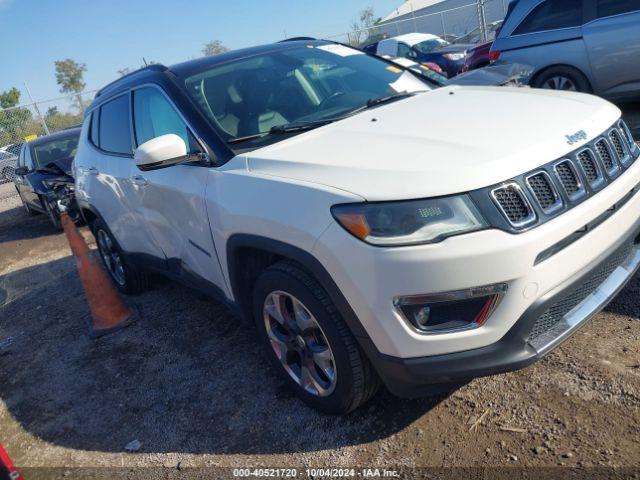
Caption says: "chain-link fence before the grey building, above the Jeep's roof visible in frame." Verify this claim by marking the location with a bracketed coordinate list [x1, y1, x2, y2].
[326, 0, 508, 47]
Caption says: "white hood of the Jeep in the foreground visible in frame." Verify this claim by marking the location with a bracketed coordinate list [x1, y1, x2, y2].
[246, 87, 620, 201]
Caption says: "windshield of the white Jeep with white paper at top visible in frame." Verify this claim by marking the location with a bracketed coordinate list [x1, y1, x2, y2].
[185, 44, 436, 147]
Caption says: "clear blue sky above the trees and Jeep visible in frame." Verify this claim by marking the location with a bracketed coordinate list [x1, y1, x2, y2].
[0, 0, 403, 103]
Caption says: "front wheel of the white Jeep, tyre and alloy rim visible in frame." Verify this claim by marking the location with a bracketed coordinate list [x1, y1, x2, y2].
[254, 262, 380, 414]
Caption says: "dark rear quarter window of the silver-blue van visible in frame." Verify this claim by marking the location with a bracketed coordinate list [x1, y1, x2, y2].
[513, 0, 582, 35]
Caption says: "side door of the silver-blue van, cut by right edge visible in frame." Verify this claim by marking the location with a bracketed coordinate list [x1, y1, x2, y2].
[583, 0, 640, 95]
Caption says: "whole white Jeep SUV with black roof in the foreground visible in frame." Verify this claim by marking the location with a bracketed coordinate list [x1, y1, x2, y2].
[75, 40, 640, 413]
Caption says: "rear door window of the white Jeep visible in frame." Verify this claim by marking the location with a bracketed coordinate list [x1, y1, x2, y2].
[98, 95, 132, 155]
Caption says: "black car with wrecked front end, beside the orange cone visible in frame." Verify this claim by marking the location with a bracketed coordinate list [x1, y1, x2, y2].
[14, 128, 80, 230]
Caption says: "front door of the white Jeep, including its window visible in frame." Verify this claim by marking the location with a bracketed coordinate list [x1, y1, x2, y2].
[133, 86, 225, 291]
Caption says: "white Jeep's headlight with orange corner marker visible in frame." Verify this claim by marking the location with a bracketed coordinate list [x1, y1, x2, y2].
[331, 195, 487, 246]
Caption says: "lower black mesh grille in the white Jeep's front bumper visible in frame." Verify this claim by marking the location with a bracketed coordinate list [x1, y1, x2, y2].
[527, 242, 636, 344]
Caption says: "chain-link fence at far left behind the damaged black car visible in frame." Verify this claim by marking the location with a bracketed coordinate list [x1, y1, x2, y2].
[0, 91, 95, 184]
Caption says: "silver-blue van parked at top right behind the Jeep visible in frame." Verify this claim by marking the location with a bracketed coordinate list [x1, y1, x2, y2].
[491, 0, 640, 99]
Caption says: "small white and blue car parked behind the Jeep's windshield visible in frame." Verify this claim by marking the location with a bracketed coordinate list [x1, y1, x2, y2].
[376, 33, 473, 78]
